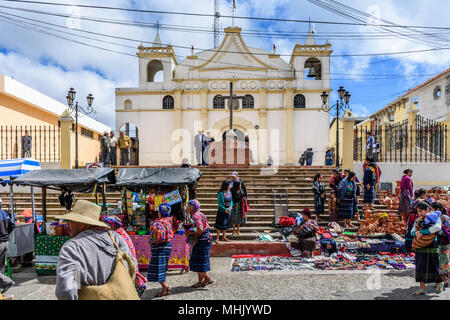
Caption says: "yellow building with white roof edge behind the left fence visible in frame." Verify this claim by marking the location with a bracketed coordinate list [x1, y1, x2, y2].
[0, 75, 111, 167]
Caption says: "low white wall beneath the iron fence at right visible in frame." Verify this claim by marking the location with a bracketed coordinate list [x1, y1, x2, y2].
[354, 162, 450, 188]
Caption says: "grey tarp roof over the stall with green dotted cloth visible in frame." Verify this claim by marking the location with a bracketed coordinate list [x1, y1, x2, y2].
[13, 168, 115, 191]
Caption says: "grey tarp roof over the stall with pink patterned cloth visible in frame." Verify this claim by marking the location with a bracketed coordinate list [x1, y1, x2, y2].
[116, 168, 202, 187]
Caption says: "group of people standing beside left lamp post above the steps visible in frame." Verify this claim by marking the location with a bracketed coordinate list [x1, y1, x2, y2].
[100, 131, 133, 167]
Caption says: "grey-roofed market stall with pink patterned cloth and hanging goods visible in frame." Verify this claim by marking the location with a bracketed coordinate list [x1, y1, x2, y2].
[116, 168, 202, 270]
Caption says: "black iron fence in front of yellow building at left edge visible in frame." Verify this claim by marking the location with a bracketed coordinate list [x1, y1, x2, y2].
[0, 125, 61, 162]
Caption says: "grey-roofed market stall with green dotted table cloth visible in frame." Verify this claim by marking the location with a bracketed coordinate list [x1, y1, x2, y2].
[13, 168, 115, 274]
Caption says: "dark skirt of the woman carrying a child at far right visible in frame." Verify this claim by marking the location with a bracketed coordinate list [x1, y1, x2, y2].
[416, 241, 442, 283]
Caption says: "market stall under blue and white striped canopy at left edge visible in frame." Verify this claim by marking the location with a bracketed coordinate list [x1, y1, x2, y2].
[0, 159, 41, 258]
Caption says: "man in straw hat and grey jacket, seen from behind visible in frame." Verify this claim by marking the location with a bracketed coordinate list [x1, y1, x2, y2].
[55, 200, 137, 300]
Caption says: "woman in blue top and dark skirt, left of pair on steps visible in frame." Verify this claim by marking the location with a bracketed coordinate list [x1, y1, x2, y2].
[214, 180, 233, 243]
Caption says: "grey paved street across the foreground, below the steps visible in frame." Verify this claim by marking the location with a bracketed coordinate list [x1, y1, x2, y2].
[7, 258, 450, 300]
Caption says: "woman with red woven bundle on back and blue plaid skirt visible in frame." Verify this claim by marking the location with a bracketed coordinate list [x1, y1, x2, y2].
[147, 203, 173, 297]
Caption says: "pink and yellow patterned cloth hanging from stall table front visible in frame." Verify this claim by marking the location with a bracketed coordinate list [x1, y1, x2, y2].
[130, 234, 189, 270]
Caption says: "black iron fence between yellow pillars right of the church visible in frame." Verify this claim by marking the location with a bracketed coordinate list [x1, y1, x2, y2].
[353, 116, 450, 162]
